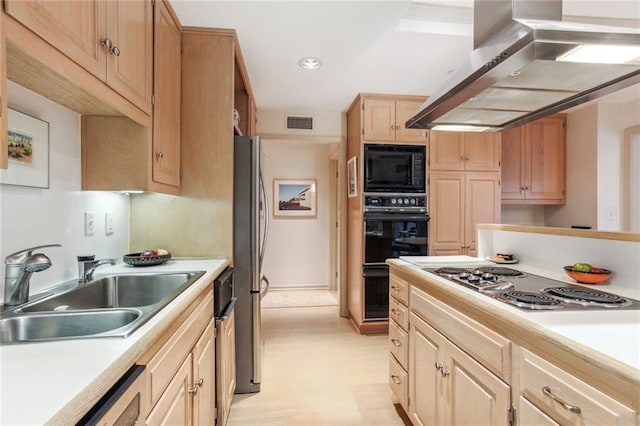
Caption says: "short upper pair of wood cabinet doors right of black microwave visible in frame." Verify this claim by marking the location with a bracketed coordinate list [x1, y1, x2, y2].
[429, 130, 501, 171]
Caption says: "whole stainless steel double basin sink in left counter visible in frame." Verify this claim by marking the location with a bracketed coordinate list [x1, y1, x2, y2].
[0, 271, 204, 344]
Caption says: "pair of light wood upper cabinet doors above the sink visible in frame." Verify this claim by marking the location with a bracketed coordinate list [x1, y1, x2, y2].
[5, 0, 153, 114]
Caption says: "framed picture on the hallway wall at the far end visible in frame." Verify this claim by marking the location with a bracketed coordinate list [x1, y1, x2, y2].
[273, 179, 317, 218]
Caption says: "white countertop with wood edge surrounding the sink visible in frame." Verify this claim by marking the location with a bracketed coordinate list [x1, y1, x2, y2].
[0, 259, 229, 425]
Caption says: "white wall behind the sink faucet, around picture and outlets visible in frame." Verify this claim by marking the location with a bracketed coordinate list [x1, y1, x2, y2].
[0, 81, 129, 300]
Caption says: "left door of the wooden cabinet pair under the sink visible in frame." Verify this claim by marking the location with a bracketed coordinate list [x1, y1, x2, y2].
[146, 354, 193, 426]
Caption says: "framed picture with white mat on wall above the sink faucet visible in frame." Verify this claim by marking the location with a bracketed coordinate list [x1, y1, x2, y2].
[0, 108, 49, 188]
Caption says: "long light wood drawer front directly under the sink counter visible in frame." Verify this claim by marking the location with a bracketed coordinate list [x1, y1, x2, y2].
[147, 291, 213, 406]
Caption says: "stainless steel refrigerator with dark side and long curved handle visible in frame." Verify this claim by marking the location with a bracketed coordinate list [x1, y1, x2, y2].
[233, 136, 269, 393]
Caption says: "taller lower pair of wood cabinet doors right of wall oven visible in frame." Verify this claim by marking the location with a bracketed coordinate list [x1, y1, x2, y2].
[429, 172, 501, 256]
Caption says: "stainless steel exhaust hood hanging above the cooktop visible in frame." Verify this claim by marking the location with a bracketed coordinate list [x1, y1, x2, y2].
[406, 0, 640, 131]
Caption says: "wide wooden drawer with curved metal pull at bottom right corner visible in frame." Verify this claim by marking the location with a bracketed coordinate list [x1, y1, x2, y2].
[518, 349, 637, 425]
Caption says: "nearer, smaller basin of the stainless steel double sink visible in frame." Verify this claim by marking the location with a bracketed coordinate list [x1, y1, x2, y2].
[0, 309, 142, 343]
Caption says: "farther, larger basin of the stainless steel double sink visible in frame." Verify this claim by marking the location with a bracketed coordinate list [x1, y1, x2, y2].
[21, 272, 202, 312]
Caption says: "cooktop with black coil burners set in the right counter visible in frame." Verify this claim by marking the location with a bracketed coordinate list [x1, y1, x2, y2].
[426, 265, 640, 311]
